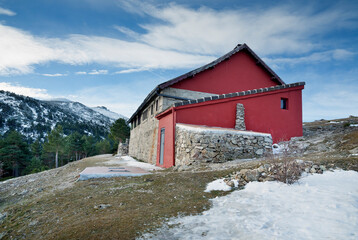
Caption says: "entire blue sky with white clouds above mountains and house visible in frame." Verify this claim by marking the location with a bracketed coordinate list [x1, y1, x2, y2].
[0, 0, 358, 121]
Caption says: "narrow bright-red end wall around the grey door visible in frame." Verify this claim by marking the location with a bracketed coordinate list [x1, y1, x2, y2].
[157, 109, 175, 168]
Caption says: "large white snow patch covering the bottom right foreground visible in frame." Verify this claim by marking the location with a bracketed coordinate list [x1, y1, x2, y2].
[143, 171, 358, 239]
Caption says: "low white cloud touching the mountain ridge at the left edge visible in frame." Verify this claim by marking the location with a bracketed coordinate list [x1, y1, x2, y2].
[0, 82, 52, 99]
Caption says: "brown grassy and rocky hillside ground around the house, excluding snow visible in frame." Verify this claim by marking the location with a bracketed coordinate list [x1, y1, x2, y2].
[0, 117, 358, 239]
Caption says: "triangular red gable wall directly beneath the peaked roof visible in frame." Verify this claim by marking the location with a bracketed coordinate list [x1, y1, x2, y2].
[171, 52, 278, 94]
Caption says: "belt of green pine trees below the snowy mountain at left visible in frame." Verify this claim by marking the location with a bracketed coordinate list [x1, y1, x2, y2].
[0, 119, 129, 180]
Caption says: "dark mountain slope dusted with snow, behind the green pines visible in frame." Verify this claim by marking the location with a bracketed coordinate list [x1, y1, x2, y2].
[0, 91, 126, 140]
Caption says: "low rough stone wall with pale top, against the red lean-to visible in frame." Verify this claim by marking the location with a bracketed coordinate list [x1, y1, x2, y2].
[175, 124, 272, 165]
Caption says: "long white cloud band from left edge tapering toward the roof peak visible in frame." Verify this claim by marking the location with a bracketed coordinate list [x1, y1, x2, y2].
[0, 24, 213, 75]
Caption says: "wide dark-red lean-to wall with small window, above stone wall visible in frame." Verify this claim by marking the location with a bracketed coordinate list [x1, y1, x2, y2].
[176, 86, 303, 142]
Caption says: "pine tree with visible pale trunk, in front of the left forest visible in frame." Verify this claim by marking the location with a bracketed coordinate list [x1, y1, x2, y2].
[44, 125, 64, 168]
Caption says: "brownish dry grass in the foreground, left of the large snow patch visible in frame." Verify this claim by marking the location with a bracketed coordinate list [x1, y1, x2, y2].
[0, 167, 238, 239]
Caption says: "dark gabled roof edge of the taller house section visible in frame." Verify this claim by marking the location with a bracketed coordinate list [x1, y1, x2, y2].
[128, 43, 285, 122]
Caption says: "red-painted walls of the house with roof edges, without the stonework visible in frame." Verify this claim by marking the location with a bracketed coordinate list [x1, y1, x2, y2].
[130, 44, 304, 167]
